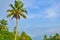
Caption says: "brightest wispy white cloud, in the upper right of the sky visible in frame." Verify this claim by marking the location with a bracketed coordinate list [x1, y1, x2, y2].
[45, 3, 60, 18]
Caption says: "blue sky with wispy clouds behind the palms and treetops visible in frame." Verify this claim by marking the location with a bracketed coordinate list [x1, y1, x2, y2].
[0, 0, 60, 40]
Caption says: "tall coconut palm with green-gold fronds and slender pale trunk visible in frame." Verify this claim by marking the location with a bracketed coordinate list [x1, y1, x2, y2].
[7, 0, 27, 40]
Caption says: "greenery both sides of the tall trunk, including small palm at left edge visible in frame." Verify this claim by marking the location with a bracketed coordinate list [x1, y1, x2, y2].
[0, 19, 32, 40]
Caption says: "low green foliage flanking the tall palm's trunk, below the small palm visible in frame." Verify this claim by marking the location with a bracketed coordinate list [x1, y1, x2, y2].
[0, 30, 32, 40]
